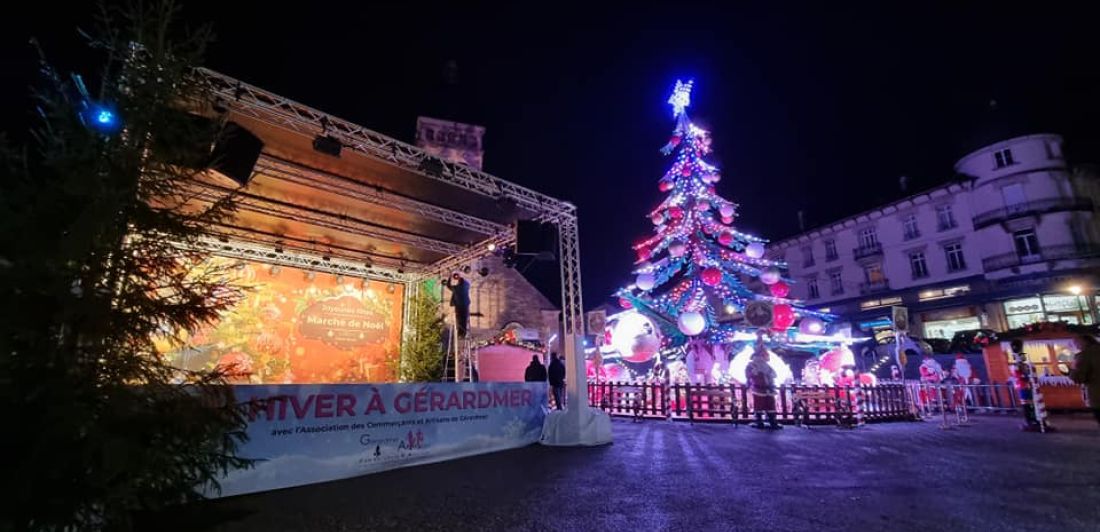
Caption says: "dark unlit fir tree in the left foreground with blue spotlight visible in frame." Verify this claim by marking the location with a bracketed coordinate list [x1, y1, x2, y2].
[0, 2, 248, 530]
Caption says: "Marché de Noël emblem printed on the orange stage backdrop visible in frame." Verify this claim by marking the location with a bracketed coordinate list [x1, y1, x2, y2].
[299, 296, 388, 348]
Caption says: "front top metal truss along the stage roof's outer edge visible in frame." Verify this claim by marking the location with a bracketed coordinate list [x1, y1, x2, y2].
[198, 68, 576, 215]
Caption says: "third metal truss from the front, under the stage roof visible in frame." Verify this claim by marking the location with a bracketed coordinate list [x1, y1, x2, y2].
[189, 184, 463, 255]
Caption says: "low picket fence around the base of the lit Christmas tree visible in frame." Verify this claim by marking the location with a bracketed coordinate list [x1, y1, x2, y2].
[589, 381, 916, 424]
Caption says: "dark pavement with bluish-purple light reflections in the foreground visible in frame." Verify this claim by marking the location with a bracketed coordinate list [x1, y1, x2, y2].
[155, 417, 1100, 532]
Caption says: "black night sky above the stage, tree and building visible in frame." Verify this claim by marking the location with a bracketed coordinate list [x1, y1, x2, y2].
[0, 0, 1100, 307]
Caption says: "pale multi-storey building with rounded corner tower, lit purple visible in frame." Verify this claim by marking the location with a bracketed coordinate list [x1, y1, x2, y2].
[770, 134, 1100, 340]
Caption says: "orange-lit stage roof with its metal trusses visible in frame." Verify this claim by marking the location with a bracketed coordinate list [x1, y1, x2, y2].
[200, 69, 575, 278]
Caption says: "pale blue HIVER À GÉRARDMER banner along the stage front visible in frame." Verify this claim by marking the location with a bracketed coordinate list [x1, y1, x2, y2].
[210, 383, 547, 497]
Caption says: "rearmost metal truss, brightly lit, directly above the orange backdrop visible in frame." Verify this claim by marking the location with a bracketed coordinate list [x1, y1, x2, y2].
[188, 237, 413, 282]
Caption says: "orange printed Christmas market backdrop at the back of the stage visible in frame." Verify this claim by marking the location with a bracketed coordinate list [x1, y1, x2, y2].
[162, 257, 405, 384]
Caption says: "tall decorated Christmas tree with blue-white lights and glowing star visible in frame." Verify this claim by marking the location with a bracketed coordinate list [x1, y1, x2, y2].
[619, 81, 828, 347]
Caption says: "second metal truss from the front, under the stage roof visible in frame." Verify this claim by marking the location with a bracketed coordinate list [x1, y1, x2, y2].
[256, 155, 508, 235]
